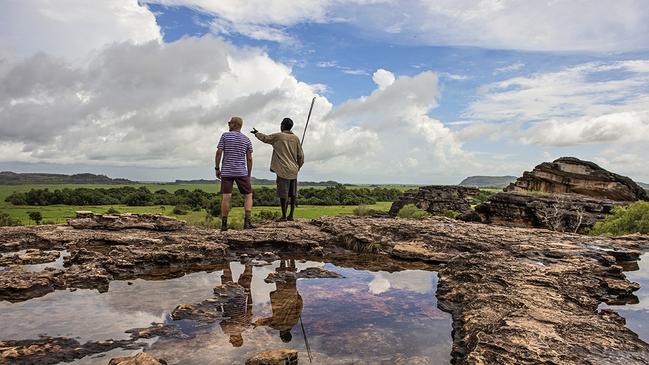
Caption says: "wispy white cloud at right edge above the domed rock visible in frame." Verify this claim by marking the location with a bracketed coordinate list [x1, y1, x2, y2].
[464, 60, 649, 146]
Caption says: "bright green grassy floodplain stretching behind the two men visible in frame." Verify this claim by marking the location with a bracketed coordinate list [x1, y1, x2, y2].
[0, 183, 417, 225]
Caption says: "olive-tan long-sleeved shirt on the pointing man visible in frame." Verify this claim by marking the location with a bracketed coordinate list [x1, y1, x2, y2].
[255, 131, 304, 180]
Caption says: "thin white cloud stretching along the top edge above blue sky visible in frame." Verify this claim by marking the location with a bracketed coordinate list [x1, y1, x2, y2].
[148, 0, 649, 51]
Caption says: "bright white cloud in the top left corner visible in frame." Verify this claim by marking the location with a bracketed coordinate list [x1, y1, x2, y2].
[0, 0, 161, 59]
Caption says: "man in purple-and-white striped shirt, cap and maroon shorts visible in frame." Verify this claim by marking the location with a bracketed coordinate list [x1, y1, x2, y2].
[214, 117, 254, 231]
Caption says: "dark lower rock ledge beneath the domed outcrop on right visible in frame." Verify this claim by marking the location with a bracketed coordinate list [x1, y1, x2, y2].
[474, 193, 624, 232]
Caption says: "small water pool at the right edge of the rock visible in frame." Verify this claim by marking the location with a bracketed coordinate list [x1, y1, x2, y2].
[611, 253, 649, 342]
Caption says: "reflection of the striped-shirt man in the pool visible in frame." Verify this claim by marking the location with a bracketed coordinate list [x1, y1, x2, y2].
[220, 262, 252, 347]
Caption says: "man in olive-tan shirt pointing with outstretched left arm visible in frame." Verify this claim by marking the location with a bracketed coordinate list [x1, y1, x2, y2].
[251, 118, 304, 221]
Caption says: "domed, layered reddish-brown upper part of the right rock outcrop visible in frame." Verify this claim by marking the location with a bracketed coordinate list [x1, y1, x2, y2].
[505, 157, 648, 201]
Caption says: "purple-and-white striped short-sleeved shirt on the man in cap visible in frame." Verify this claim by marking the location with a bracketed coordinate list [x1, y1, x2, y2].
[217, 131, 252, 177]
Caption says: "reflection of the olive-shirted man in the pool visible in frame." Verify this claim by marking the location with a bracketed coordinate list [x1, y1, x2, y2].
[255, 260, 302, 342]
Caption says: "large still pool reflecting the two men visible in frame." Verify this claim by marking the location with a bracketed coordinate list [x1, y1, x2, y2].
[0, 260, 450, 364]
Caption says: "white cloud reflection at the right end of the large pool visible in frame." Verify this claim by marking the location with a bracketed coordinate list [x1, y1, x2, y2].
[369, 270, 437, 294]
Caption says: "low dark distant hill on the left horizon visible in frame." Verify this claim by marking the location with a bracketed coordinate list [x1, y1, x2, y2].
[0, 171, 133, 185]
